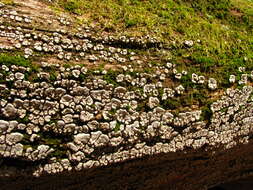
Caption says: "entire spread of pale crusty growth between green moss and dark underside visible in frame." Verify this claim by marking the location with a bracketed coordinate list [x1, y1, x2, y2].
[0, 1, 253, 189]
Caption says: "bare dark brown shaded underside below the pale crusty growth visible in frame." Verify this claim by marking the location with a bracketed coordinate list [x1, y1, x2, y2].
[0, 142, 253, 190]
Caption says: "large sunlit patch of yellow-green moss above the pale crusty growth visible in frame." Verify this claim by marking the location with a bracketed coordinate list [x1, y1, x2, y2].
[56, 0, 253, 90]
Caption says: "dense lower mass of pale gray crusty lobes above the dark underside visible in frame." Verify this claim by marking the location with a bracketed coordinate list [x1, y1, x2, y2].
[0, 63, 253, 176]
